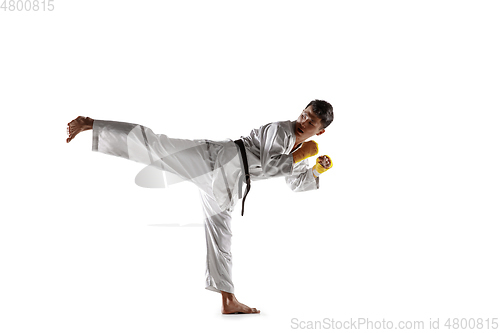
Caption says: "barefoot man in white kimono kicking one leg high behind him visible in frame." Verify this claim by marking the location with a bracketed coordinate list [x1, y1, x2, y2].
[66, 100, 333, 314]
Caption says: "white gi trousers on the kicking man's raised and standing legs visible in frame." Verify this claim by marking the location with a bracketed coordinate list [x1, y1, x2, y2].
[92, 119, 234, 293]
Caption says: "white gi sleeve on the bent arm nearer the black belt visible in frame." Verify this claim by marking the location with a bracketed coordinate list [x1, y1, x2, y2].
[259, 123, 293, 177]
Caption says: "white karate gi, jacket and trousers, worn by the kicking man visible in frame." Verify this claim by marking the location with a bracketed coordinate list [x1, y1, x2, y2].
[92, 119, 319, 293]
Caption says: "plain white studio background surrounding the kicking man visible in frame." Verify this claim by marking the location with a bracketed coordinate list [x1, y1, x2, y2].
[0, 0, 500, 332]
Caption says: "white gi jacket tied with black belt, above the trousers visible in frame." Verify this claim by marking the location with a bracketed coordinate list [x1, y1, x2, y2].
[210, 121, 319, 211]
